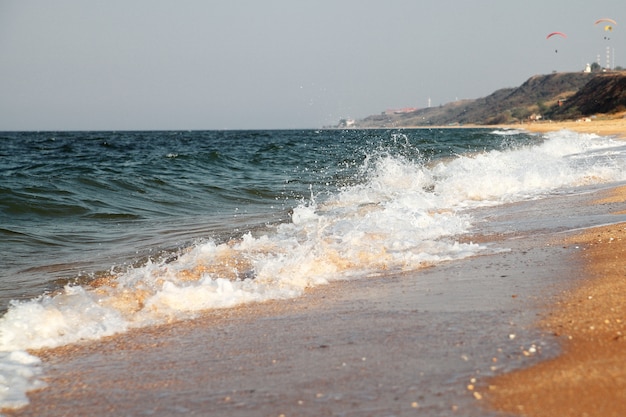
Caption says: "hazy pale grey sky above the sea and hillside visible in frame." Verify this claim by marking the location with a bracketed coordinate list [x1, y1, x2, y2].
[0, 0, 626, 131]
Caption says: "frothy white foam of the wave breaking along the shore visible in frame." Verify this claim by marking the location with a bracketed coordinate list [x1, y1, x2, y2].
[0, 131, 626, 407]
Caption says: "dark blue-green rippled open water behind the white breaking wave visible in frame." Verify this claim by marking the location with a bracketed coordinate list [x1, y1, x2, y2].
[0, 129, 536, 310]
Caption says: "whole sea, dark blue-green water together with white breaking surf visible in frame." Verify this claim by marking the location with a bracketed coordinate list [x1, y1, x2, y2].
[0, 128, 626, 408]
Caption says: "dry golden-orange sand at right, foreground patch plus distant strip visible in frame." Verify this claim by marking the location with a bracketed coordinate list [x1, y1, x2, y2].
[485, 118, 626, 417]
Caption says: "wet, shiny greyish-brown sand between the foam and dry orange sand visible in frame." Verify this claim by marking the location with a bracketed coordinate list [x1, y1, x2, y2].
[6, 199, 596, 417]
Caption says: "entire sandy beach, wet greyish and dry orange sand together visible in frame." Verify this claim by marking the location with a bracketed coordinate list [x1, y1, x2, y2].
[4, 119, 626, 417]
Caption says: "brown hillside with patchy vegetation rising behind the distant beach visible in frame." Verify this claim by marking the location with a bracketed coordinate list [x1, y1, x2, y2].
[346, 71, 626, 128]
